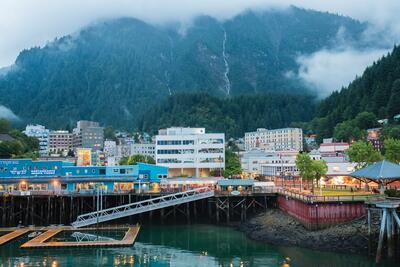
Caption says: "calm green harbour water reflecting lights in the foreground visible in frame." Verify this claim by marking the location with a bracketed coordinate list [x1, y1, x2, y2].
[0, 225, 396, 267]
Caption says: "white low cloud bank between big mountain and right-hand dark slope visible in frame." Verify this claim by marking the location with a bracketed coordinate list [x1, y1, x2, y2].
[297, 47, 390, 97]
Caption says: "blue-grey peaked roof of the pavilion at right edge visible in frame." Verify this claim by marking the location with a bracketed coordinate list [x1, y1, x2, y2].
[350, 160, 400, 180]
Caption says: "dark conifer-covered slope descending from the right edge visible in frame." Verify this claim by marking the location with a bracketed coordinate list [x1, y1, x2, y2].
[310, 46, 400, 137]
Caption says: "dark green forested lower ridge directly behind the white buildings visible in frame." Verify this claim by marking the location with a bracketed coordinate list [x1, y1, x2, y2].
[138, 92, 315, 137]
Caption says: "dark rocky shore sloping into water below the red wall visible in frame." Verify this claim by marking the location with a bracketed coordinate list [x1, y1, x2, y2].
[239, 209, 379, 254]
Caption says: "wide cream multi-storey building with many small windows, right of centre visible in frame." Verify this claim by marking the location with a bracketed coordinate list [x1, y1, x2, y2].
[244, 128, 303, 151]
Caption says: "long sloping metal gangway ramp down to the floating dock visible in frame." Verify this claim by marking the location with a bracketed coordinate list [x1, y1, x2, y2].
[71, 187, 214, 228]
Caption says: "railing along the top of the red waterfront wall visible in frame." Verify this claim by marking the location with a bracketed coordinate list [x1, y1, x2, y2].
[278, 189, 381, 203]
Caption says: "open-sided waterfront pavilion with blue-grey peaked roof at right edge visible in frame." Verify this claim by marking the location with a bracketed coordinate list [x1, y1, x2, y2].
[349, 160, 400, 193]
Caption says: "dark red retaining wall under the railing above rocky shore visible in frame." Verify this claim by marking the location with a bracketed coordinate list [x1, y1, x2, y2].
[278, 196, 367, 229]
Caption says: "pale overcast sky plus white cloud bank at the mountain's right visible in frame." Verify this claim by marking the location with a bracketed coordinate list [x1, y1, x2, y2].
[0, 0, 400, 98]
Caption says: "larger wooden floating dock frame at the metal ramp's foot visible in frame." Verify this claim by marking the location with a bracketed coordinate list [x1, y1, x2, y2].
[21, 226, 140, 248]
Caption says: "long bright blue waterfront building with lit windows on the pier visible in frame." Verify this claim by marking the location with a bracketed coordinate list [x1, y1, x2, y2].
[0, 159, 168, 192]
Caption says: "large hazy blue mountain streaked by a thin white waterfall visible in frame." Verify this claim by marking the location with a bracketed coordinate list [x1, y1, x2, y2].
[0, 7, 366, 128]
